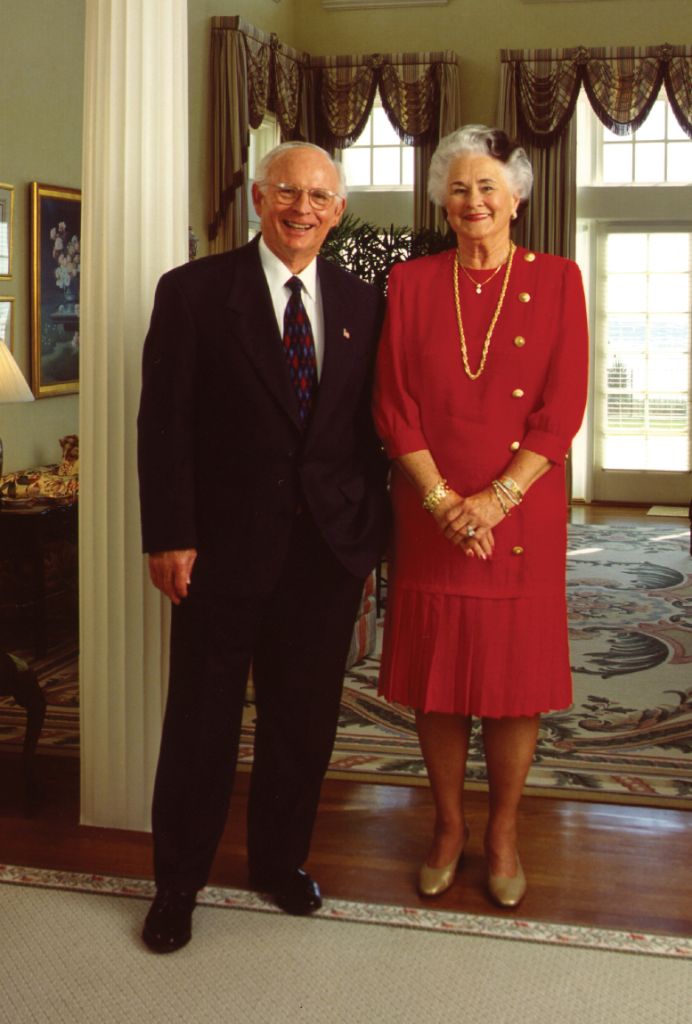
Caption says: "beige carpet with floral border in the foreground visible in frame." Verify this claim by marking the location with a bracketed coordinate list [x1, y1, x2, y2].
[0, 868, 692, 1024]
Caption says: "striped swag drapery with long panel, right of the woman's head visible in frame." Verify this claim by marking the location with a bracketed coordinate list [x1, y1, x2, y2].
[498, 45, 692, 258]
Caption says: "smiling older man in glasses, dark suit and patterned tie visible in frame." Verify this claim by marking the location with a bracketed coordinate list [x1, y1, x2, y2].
[139, 142, 388, 952]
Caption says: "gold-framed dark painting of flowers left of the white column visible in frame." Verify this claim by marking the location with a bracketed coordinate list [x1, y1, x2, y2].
[30, 181, 82, 398]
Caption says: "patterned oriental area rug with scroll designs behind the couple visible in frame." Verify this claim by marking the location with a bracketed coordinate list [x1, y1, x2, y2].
[0, 524, 692, 809]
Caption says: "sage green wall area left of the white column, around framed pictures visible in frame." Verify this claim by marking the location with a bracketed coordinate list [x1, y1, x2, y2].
[0, 0, 85, 472]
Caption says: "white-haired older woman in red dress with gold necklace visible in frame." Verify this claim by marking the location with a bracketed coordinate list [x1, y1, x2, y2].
[375, 125, 588, 906]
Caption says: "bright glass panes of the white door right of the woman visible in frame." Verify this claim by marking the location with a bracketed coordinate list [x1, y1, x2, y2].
[597, 227, 692, 471]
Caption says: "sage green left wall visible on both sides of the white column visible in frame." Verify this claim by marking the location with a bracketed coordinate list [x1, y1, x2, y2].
[0, 0, 296, 472]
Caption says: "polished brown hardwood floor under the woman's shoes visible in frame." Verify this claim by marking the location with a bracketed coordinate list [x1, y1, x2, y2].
[0, 506, 692, 936]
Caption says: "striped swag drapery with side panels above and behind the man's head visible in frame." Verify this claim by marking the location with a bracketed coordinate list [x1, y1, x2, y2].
[209, 16, 460, 252]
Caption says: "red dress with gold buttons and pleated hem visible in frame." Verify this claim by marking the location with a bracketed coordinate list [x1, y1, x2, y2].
[374, 243, 589, 718]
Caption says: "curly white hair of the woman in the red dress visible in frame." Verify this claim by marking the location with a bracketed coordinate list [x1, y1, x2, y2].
[428, 125, 533, 209]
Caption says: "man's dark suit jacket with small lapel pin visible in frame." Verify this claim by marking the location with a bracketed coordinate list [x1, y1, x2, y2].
[138, 240, 388, 593]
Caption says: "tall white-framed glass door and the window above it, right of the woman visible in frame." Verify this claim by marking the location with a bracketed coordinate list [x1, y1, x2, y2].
[577, 94, 692, 504]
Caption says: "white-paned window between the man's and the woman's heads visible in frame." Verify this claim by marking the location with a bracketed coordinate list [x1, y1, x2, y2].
[341, 97, 414, 191]
